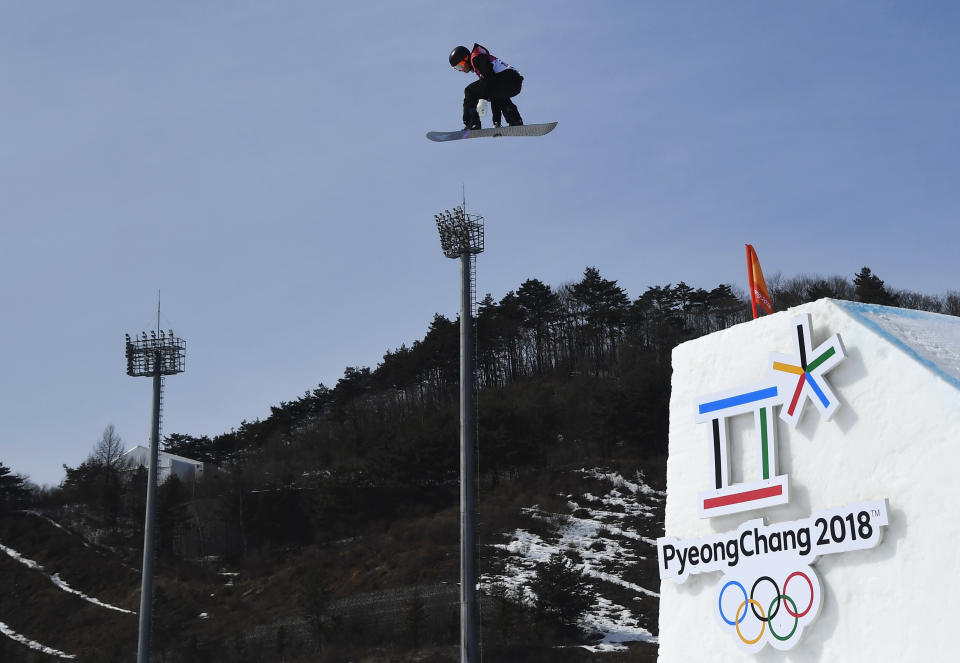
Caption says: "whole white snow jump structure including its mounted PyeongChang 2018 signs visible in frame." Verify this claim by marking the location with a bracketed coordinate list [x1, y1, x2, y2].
[658, 299, 960, 663]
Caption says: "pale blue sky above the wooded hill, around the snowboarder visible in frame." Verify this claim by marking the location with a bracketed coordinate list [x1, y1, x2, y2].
[0, 0, 960, 484]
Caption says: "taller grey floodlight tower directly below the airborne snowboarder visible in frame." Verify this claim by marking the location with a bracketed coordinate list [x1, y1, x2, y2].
[434, 203, 483, 663]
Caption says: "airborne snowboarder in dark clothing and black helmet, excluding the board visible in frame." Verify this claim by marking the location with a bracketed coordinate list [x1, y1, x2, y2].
[450, 44, 523, 130]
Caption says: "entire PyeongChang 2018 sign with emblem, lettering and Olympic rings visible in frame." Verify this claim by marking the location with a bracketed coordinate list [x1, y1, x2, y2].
[657, 315, 888, 652]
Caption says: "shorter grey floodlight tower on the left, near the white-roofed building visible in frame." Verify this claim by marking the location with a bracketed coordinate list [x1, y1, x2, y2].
[126, 326, 187, 663]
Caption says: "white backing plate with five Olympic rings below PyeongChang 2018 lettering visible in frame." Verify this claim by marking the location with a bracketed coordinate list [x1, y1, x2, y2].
[714, 565, 823, 653]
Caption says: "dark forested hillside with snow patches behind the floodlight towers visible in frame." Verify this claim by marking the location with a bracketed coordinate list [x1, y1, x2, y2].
[0, 268, 960, 661]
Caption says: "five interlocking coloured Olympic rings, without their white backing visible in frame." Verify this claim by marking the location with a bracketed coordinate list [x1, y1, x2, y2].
[717, 570, 819, 649]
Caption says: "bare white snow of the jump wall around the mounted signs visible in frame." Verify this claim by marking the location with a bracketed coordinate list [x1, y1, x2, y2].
[659, 299, 960, 663]
